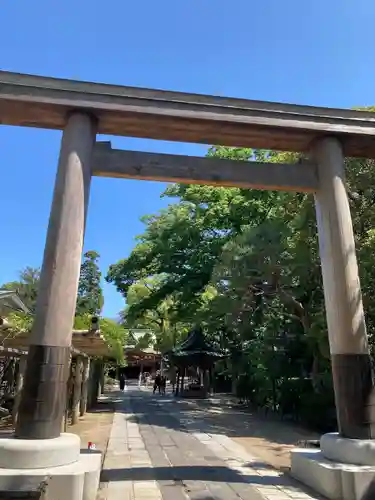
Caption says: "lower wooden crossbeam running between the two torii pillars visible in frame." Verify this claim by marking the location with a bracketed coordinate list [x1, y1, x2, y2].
[93, 143, 318, 192]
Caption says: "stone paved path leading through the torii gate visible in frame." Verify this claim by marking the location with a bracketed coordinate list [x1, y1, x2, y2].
[99, 386, 319, 500]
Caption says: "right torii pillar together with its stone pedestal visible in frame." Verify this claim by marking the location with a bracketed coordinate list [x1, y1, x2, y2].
[291, 137, 375, 500]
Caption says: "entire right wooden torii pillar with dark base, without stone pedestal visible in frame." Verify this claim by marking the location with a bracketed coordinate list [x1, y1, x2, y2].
[313, 137, 374, 439]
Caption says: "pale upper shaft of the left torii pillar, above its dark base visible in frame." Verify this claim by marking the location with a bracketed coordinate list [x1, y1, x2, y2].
[30, 113, 95, 346]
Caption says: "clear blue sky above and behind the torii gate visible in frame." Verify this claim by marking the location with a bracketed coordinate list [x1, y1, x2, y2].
[0, 0, 375, 317]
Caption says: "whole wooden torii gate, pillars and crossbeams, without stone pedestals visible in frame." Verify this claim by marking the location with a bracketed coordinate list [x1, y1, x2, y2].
[0, 72, 375, 439]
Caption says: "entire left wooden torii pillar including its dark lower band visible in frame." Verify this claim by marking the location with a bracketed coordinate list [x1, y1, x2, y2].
[15, 112, 96, 439]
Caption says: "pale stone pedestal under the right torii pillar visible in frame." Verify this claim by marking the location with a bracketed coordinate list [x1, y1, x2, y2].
[291, 433, 375, 500]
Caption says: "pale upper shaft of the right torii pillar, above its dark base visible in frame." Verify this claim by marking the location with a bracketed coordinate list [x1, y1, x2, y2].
[312, 138, 369, 354]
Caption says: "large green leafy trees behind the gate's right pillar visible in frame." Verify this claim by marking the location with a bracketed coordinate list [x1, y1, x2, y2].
[106, 134, 375, 434]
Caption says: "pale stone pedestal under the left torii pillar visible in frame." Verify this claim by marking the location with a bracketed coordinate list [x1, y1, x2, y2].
[0, 434, 101, 500]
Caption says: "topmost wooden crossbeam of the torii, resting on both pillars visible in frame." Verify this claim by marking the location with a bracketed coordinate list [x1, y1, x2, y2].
[0, 71, 375, 158]
